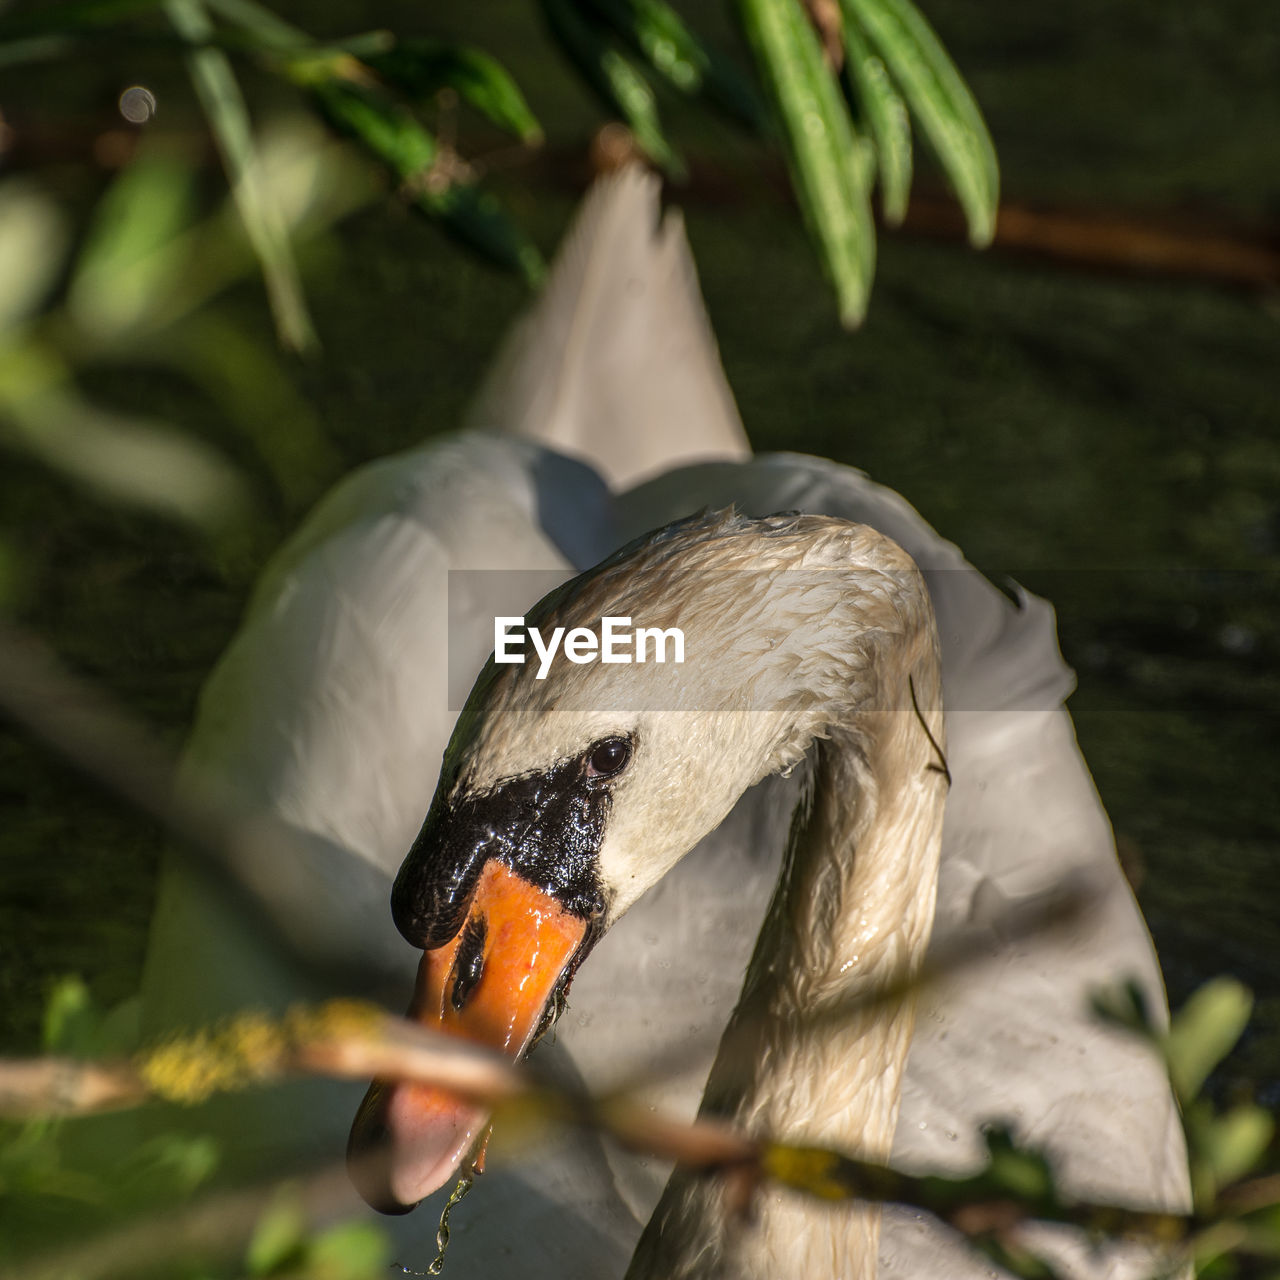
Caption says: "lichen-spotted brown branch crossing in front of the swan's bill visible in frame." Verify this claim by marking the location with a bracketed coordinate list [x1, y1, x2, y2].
[0, 1001, 1204, 1275]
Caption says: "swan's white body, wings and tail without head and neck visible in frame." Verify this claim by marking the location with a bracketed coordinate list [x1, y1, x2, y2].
[146, 175, 1187, 1280]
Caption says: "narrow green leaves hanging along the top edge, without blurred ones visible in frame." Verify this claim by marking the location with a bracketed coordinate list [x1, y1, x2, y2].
[0, 0, 998, 349]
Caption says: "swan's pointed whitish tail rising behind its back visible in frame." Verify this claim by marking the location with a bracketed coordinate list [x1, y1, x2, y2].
[467, 166, 750, 489]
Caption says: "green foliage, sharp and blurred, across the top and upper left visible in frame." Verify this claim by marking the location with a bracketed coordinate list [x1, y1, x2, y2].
[0, 0, 997, 593]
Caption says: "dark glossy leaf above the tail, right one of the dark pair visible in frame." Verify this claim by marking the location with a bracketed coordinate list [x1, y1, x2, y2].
[586, 0, 764, 129]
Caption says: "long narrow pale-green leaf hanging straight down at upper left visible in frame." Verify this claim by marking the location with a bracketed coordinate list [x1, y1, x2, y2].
[165, 0, 316, 351]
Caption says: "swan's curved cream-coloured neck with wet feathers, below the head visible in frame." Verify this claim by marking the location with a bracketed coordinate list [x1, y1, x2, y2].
[628, 612, 946, 1280]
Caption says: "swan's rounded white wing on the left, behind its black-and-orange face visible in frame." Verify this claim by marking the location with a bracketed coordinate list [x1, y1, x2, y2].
[145, 435, 609, 1013]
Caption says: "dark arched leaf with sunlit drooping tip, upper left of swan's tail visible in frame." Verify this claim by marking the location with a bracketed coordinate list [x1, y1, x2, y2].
[365, 40, 543, 143]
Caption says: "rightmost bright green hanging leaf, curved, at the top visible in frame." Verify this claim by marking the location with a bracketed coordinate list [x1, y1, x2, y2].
[842, 0, 1000, 247]
